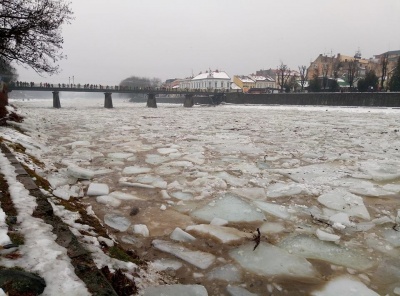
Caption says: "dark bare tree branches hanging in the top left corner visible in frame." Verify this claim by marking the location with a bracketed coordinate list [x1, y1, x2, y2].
[0, 0, 73, 74]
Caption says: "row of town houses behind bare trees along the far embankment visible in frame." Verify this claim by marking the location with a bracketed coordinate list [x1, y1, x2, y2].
[163, 50, 400, 93]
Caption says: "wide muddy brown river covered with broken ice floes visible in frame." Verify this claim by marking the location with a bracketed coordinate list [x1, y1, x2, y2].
[0, 99, 400, 295]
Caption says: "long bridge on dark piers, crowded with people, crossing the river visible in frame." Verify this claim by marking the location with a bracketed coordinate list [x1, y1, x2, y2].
[8, 82, 227, 108]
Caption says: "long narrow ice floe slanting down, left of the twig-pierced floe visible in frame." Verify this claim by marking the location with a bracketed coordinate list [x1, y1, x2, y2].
[153, 240, 215, 270]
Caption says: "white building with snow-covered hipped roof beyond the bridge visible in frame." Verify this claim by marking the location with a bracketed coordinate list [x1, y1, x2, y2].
[190, 70, 231, 90]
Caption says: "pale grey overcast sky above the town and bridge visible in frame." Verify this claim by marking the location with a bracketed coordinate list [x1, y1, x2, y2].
[13, 0, 400, 85]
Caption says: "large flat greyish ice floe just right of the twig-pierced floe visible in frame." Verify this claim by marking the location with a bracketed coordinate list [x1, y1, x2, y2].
[278, 234, 375, 270]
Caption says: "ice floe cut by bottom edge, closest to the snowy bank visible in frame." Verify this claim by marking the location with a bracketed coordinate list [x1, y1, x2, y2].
[143, 284, 208, 296]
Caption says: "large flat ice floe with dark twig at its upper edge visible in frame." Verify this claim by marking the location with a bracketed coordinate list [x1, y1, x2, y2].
[229, 242, 318, 278]
